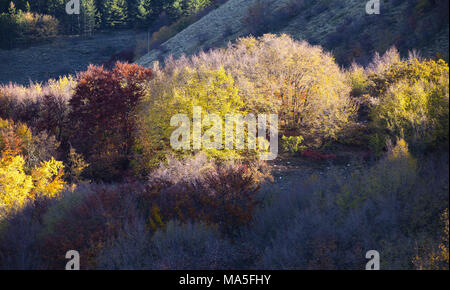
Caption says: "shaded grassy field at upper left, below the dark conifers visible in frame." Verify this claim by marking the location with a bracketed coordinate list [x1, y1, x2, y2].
[0, 30, 147, 84]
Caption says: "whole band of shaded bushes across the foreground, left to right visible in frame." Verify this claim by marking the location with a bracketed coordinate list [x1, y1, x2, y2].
[0, 142, 442, 269]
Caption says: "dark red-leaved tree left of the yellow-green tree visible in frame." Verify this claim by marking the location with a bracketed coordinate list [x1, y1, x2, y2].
[69, 63, 152, 180]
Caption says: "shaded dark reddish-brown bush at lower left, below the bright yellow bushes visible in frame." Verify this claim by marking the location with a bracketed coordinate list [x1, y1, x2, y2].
[39, 185, 143, 269]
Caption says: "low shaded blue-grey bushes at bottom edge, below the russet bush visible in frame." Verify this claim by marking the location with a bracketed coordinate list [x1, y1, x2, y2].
[99, 221, 234, 270]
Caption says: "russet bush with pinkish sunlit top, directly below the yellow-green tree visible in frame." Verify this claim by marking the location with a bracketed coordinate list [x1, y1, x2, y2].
[141, 155, 267, 234]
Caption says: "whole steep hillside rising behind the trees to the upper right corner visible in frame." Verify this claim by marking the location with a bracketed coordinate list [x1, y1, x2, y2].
[137, 0, 449, 65]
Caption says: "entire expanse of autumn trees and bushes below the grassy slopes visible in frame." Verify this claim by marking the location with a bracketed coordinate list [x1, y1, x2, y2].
[0, 30, 449, 269]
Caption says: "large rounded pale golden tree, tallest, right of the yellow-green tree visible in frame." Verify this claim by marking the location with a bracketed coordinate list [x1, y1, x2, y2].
[160, 35, 356, 146]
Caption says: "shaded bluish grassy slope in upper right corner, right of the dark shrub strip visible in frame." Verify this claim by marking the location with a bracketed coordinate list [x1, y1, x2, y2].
[281, 0, 449, 64]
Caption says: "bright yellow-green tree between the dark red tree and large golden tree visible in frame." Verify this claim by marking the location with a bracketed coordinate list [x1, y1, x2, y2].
[134, 67, 246, 172]
